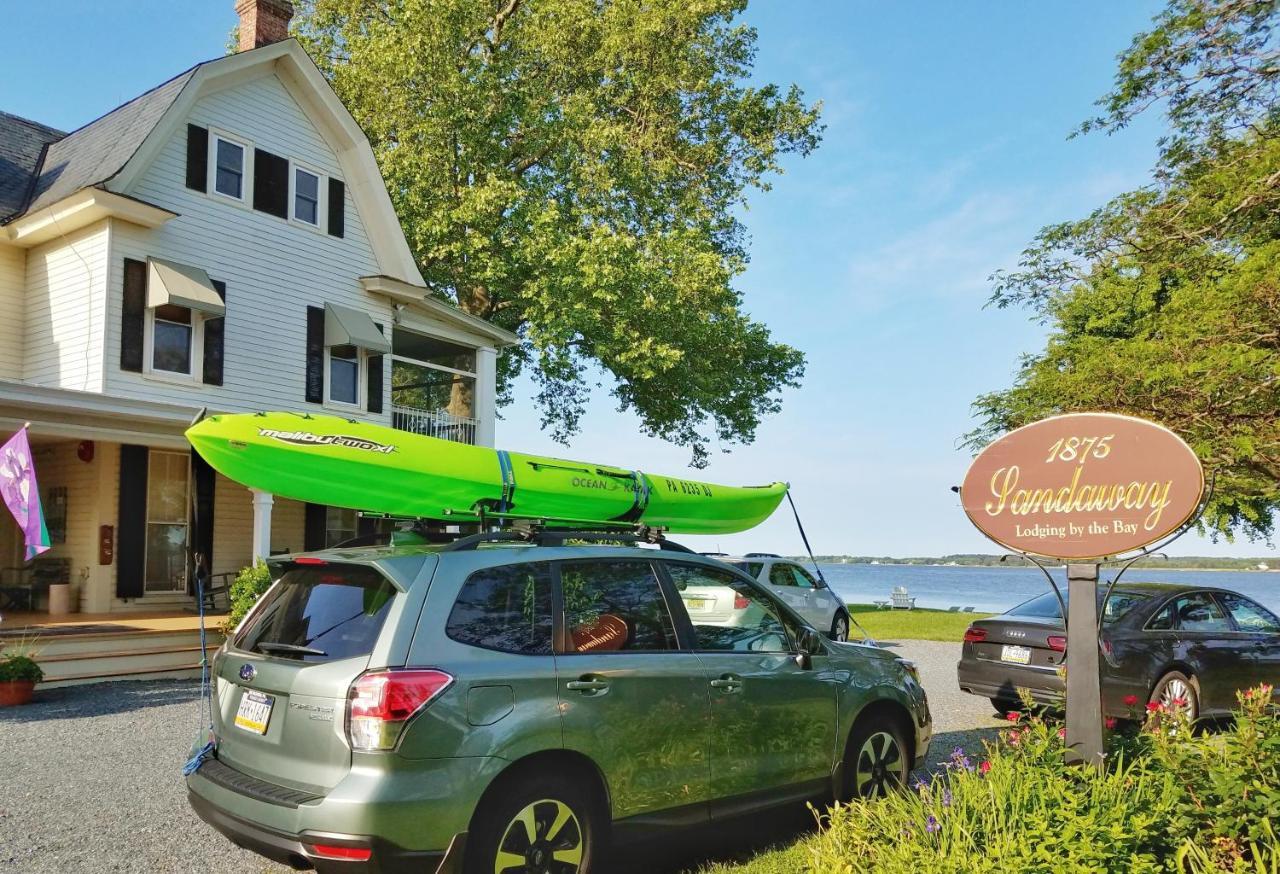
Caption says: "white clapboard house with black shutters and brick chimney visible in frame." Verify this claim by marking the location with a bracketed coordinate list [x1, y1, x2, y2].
[0, 0, 516, 675]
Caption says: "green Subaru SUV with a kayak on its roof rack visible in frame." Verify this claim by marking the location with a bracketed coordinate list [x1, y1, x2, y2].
[187, 535, 932, 874]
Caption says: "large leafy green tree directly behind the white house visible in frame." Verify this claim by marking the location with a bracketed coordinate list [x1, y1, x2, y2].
[296, 0, 820, 465]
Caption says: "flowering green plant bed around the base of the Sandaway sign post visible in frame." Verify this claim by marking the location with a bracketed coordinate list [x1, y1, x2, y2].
[712, 687, 1280, 874]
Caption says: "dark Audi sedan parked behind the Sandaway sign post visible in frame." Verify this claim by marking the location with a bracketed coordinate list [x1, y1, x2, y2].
[956, 582, 1280, 719]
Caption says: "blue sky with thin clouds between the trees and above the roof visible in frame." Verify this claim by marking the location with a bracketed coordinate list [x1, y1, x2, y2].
[0, 0, 1274, 555]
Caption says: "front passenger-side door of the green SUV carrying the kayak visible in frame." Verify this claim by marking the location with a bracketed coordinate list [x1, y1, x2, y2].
[663, 562, 836, 799]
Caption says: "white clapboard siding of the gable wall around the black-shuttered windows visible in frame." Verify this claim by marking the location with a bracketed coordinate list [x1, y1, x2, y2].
[106, 74, 392, 424]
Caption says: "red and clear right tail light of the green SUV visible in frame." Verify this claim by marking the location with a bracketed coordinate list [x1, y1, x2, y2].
[347, 669, 453, 750]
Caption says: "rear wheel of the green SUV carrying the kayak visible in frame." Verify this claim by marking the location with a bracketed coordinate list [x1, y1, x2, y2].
[463, 772, 604, 874]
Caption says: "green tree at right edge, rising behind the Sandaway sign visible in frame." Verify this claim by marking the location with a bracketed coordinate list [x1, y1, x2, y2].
[969, 0, 1280, 539]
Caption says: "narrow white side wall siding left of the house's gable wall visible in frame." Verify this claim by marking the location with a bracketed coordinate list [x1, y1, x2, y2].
[22, 220, 110, 392]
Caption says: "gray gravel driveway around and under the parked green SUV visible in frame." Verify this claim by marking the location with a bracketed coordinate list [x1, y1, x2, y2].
[0, 641, 1000, 874]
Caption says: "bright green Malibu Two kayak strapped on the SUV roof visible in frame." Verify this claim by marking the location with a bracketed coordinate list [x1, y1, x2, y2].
[187, 412, 787, 534]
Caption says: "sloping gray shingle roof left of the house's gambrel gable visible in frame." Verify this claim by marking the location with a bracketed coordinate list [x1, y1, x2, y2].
[0, 64, 200, 221]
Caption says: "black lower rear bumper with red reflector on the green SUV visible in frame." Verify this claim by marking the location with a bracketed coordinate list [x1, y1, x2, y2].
[187, 788, 461, 874]
